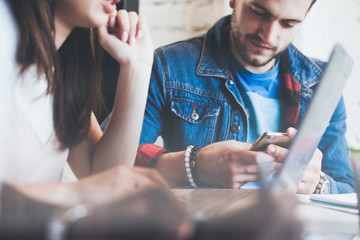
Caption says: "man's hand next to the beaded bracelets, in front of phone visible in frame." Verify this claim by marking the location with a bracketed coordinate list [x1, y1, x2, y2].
[196, 140, 274, 188]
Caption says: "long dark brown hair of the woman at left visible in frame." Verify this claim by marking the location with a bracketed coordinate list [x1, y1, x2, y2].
[8, 0, 102, 148]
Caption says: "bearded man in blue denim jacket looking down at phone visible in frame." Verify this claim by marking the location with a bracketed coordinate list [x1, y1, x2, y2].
[136, 0, 354, 194]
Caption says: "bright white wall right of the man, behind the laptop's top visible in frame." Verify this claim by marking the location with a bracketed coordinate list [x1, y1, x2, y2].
[297, 0, 360, 146]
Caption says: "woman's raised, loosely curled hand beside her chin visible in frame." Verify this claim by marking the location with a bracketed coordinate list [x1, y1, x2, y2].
[98, 10, 153, 67]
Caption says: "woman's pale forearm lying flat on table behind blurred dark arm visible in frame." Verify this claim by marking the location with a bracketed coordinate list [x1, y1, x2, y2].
[12, 166, 168, 207]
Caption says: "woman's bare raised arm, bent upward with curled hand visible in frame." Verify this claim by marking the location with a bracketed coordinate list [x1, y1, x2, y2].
[68, 10, 153, 177]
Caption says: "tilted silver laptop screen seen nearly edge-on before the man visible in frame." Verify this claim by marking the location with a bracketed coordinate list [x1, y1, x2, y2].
[270, 45, 353, 193]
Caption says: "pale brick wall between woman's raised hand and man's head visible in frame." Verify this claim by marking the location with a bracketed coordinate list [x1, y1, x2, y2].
[139, 0, 230, 47]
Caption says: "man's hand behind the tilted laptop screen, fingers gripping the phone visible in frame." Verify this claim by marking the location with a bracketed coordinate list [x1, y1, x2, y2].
[266, 128, 322, 194]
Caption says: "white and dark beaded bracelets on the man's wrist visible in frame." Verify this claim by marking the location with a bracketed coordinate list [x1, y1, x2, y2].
[185, 145, 200, 188]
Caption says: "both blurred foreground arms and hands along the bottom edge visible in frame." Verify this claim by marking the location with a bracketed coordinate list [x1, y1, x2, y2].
[0, 185, 301, 240]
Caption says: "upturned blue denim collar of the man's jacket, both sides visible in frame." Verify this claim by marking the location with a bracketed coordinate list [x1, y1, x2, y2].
[196, 15, 324, 88]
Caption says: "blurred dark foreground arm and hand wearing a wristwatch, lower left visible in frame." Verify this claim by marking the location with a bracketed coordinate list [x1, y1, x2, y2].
[0, 185, 192, 240]
